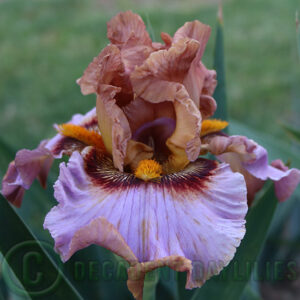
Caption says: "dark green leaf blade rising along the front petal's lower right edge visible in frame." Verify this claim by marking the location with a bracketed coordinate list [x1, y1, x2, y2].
[192, 183, 278, 300]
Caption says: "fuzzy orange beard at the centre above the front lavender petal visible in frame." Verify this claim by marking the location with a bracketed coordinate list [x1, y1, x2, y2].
[134, 159, 162, 181]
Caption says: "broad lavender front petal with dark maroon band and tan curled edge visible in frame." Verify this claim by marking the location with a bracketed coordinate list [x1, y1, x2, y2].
[44, 147, 247, 295]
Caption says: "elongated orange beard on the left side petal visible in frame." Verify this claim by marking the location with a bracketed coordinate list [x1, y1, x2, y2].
[57, 124, 105, 151]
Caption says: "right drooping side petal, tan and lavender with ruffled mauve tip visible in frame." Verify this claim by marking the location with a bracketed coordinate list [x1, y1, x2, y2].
[204, 136, 300, 202]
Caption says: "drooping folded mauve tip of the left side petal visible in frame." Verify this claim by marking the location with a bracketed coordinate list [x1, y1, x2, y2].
[1, 141, 54, 207]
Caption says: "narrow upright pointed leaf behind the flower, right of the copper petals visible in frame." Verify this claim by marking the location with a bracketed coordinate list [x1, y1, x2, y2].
[213, 7, 228, 120]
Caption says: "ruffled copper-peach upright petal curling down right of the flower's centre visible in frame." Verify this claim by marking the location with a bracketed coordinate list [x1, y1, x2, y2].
[131, 39, 201, 171]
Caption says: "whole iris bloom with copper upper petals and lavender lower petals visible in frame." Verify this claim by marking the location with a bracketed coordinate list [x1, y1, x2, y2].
[2, 11, 300, 299]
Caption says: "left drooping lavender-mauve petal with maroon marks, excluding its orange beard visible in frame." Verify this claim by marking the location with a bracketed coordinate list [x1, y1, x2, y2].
[1, 108, 99, 207]
